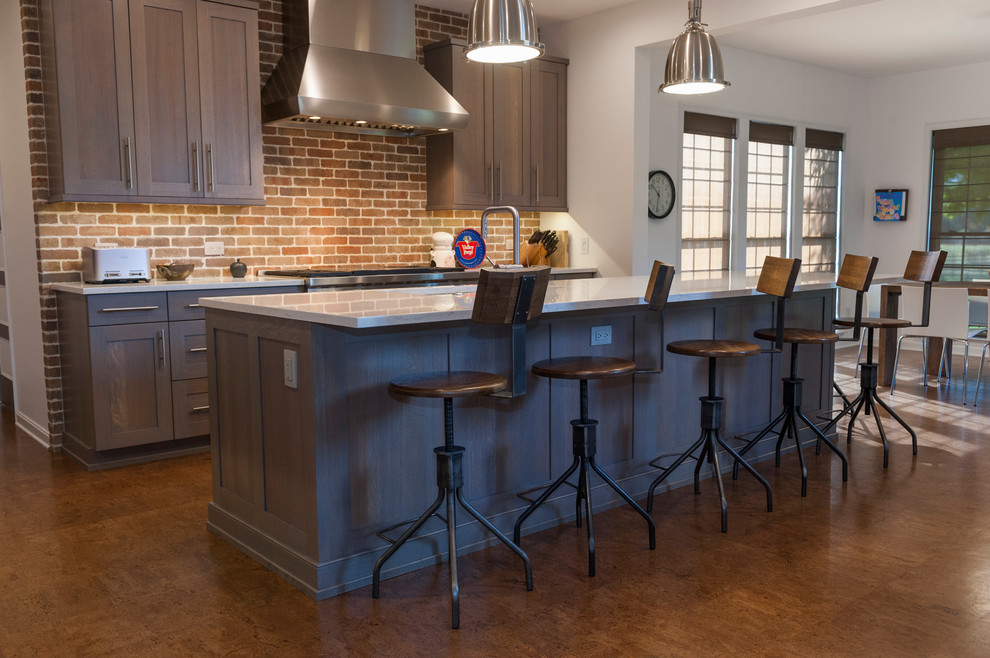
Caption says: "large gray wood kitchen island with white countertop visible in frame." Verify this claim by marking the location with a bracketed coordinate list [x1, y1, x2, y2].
[202, 275, 835, 599]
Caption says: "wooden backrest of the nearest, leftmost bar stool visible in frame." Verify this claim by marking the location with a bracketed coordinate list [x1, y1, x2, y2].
[471, 265, 550, 324]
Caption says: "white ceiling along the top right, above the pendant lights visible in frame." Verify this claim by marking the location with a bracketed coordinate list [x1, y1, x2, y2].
[432, 0, 990, 77]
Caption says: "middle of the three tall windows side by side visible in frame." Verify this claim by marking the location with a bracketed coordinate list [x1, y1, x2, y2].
[746, 121, 794, 274]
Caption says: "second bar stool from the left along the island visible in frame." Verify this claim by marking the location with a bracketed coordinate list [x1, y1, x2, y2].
[512, 262, 674, 576]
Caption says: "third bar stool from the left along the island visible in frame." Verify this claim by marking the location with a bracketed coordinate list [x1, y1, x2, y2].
[646, 256, 801, 532]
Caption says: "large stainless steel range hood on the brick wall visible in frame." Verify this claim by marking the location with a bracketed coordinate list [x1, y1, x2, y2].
[261, 0, 468, 137]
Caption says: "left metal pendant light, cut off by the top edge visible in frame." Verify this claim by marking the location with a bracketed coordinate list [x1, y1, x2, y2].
[464, 0, 545, 64]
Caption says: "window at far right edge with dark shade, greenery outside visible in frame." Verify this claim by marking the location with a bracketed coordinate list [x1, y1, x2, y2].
[928, 126, 990, 281]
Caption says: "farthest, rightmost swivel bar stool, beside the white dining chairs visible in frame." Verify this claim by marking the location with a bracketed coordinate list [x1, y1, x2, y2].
[822, 251, 946, 468]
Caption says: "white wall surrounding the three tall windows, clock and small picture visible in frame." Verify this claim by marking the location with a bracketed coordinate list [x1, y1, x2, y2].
[542, 0, 990, 276]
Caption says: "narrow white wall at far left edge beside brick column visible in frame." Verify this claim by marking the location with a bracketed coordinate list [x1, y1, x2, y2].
[0, 1, 51, 445]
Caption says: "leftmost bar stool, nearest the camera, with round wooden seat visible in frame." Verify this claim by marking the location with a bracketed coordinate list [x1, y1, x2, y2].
[371, 267, 550, 628]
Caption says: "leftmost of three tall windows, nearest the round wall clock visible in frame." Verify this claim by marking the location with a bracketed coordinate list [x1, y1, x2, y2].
[680, 112, 736, 278]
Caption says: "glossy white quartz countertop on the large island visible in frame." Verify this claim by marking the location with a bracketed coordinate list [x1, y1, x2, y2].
[200, 274, 835, 329]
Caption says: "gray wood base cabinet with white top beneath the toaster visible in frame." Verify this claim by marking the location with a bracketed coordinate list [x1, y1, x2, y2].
[56, 286, 301, 470]
